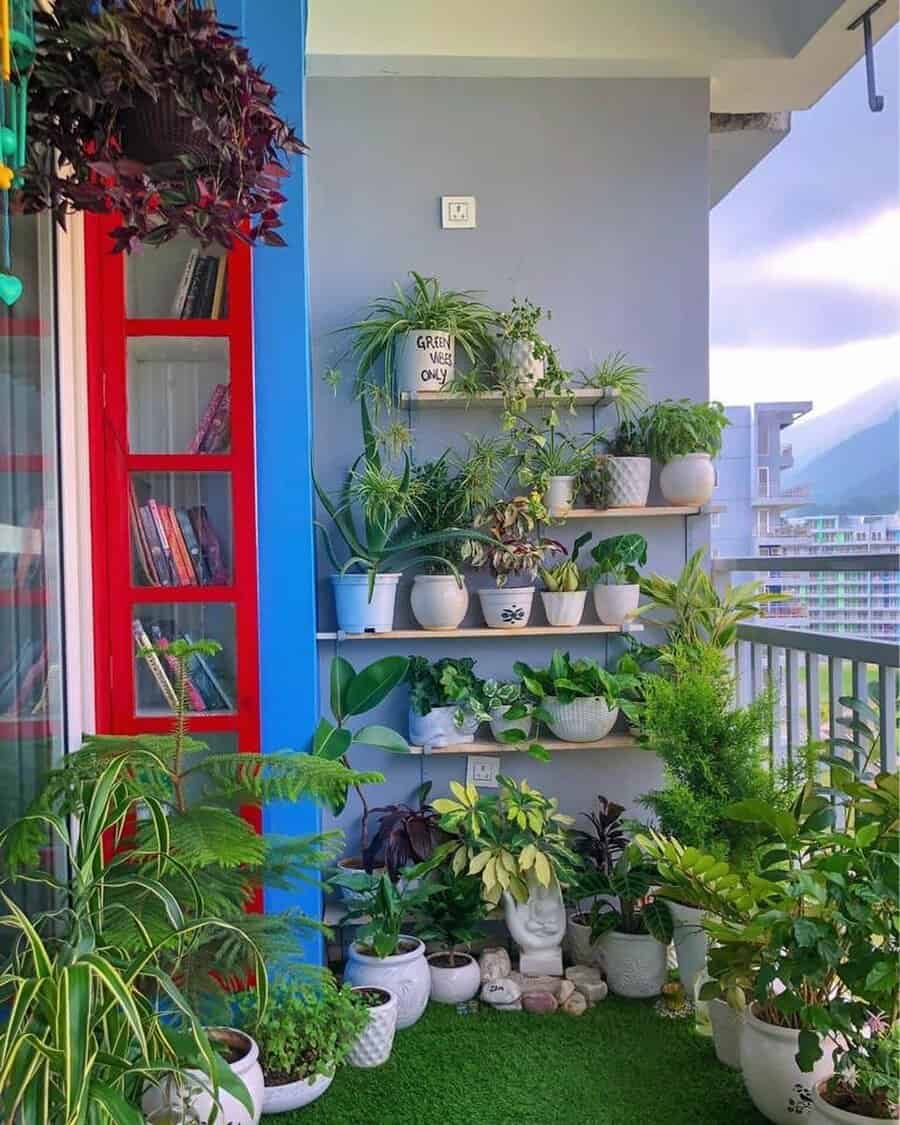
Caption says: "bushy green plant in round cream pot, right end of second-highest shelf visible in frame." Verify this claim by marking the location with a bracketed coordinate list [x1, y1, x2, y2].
[646, 398, 729, 507]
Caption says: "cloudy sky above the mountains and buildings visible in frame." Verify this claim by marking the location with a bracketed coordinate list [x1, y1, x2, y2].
[710, 28, 900, 423]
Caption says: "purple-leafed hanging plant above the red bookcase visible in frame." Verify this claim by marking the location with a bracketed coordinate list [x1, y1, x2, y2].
[23, 0, 306, 251]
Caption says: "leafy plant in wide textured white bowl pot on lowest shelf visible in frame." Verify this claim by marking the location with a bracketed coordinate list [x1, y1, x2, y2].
[513, 649, 638, 743]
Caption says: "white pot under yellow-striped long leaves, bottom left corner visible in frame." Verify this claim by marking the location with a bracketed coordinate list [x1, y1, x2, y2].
[141, 1027, 264, 1125]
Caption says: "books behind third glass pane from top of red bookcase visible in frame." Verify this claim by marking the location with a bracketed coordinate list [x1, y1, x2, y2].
[128, 485, 228, 586]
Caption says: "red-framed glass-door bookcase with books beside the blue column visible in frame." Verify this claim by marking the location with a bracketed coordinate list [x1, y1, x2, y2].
[86, 217, 260, 829]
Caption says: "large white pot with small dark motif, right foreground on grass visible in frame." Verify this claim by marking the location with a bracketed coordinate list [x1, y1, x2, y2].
[740, 1008, 834, 1125]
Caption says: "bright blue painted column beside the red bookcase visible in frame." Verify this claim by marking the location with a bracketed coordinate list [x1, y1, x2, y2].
[217, 0, 322, 962]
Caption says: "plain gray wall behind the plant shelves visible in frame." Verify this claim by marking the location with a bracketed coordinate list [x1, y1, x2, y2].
[308, 78, 709, 848]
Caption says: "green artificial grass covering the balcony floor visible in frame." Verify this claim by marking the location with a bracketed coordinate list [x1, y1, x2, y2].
[274, 997, 765, 1125]
